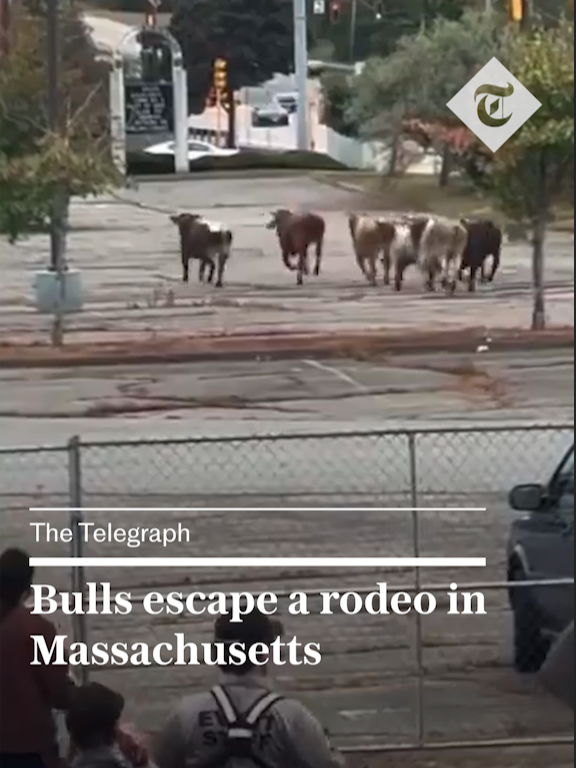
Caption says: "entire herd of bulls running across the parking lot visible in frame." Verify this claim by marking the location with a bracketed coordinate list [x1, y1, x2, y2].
[170, 209, 503, 293]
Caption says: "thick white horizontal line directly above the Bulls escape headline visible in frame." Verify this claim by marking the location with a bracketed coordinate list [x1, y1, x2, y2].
[30, 557, 486, 568]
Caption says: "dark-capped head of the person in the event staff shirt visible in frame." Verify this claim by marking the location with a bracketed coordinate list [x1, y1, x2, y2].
[214, 608, 284, 676]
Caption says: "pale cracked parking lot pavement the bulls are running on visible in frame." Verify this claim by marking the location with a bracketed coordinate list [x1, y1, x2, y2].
[0, 177, 574, 343]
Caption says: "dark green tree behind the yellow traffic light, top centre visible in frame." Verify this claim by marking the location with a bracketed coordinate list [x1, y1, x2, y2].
[170, 0, 294, 146]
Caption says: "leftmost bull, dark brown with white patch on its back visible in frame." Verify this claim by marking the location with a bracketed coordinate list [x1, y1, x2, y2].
[170, 213, 233, 288]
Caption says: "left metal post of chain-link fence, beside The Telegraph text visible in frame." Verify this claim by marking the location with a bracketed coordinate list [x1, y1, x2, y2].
[68, 436, 89, 685]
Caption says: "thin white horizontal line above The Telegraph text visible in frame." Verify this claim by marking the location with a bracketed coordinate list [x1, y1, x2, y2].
[28, 506, 487, 512]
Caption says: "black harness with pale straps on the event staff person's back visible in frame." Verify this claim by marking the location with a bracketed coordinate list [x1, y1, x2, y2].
[201, 685, 282, 768]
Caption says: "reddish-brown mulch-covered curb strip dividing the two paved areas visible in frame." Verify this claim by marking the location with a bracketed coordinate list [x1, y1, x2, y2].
[0, 327, 574, 369]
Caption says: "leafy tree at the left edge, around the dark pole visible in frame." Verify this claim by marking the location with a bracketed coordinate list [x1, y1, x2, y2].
[0, 0, 116, 246]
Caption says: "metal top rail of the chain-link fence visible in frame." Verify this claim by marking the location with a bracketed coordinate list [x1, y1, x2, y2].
[0, 421, 574, 455]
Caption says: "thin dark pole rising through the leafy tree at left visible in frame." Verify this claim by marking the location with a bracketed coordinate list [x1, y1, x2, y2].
[46, 0, 66, 347]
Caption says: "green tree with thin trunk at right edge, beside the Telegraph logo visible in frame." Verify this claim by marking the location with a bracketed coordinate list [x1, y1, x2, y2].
[474, 21, 574, 330]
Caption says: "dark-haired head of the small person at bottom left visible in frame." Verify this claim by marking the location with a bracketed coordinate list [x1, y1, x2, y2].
[66, 683, 124, 750]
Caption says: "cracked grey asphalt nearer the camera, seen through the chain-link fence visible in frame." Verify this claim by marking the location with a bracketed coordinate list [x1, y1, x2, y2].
[0, 353, 573, 744]
